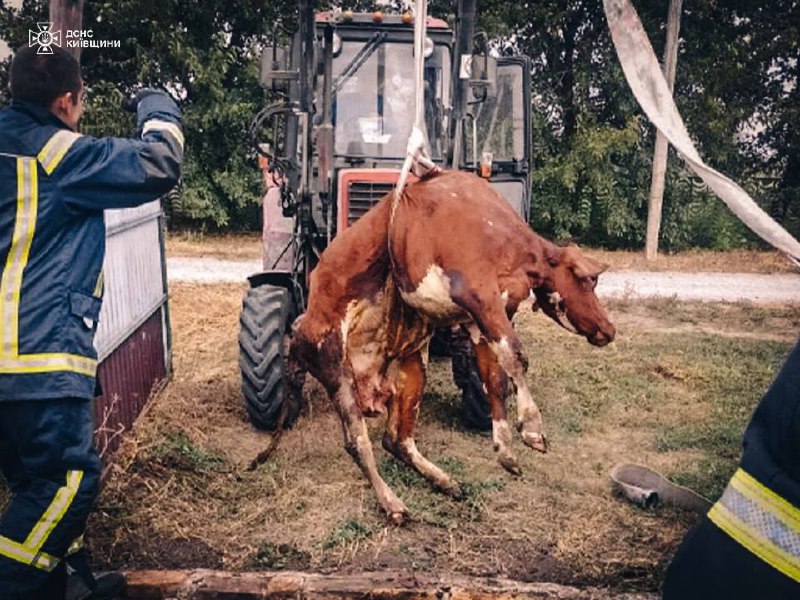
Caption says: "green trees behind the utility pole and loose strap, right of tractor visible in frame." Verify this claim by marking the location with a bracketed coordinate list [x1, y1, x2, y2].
[480, 0, 800, 250]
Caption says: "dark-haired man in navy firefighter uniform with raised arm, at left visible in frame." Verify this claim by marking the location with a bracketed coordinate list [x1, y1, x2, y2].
[0, 46, 183, 600]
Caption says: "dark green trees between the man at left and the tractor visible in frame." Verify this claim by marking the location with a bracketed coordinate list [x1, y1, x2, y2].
[0, 0, 284, 229]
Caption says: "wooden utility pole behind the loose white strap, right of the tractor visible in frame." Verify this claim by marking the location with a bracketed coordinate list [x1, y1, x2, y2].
[645, 0, 682, 262]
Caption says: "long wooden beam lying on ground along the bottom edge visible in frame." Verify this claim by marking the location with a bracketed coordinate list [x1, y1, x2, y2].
[125, 569, 657, 600]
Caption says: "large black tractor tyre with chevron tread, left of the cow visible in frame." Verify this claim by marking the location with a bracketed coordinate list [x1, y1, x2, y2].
[239, 285, 302, 431]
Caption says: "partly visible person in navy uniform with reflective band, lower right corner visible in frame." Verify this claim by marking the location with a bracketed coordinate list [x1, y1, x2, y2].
[664, 342, 800, 600]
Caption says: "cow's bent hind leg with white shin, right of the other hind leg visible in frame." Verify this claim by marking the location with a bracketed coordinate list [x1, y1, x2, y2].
[383, 352, 462, 498]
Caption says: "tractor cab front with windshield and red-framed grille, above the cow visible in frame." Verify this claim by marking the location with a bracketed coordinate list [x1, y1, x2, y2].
[314, 12, 453, 233]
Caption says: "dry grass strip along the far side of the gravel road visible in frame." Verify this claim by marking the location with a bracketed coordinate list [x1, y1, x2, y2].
[167, 232, 797, 273]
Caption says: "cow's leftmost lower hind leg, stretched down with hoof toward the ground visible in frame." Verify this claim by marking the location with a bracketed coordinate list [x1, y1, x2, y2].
[333, 382, 408, 525]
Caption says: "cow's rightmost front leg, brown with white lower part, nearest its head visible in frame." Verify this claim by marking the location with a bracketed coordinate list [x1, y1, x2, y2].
[453, 289, 547, 452]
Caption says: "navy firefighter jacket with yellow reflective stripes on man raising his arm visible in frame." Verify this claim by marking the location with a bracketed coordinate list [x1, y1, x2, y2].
[0, 93, 183, 401]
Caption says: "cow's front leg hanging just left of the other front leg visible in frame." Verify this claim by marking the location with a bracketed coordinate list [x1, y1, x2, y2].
[475, 339, 522, 475]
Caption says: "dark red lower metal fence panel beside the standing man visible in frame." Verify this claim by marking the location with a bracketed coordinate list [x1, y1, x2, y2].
[95, 307, 167, 459]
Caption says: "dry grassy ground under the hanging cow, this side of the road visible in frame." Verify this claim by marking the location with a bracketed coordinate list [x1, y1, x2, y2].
[88, 284, 800, 591]
